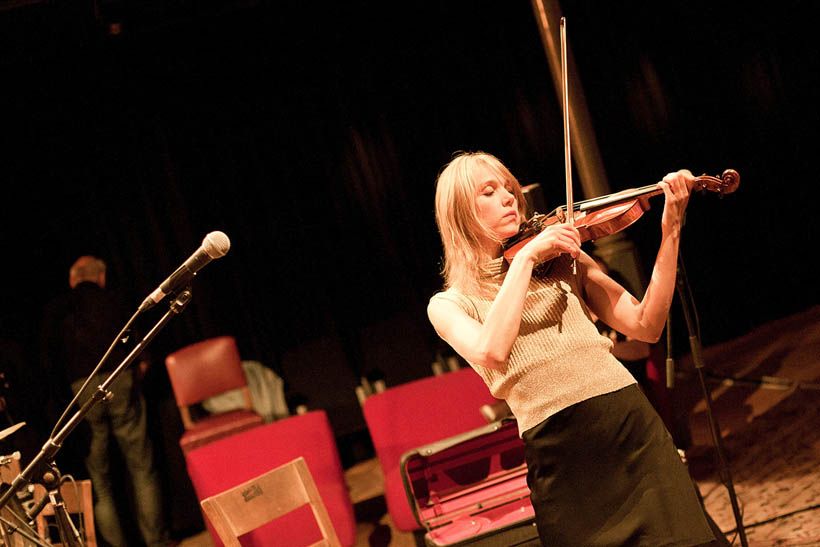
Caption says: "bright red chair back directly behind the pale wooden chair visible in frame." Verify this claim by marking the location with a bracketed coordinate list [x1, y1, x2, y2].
[185, 410, 356, 546]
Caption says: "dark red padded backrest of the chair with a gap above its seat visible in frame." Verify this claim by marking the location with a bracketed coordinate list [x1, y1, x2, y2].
[165, 336, 253, 429]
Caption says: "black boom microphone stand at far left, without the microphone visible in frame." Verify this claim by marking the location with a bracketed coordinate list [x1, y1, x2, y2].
[0, 287, 192, 547]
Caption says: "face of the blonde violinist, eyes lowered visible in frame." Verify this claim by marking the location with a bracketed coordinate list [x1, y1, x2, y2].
[475, 166, 521, 239]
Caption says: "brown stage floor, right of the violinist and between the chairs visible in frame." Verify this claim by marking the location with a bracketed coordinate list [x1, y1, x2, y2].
[180, 307, 820, 547]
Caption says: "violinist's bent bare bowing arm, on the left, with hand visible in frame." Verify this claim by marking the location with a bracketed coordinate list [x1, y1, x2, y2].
[427, 224, 581, 369]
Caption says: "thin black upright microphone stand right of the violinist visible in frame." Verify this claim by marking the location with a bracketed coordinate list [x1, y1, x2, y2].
[667, 253, 748, 547]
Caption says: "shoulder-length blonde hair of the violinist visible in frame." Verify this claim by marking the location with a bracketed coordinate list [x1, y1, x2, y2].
[436, 152, 526, 294]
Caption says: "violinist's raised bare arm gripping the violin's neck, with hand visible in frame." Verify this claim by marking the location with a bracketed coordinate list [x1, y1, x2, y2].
[579, 170, 694, 342]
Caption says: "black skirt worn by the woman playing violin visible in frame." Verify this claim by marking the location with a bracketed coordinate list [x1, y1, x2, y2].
[523, 384, 715, 547]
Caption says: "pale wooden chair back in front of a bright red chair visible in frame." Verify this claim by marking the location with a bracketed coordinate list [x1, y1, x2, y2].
[200, 457, 341, 547]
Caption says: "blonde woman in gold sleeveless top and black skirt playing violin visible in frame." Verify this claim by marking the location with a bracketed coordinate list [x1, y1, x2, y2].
[428, 153, 715, 546]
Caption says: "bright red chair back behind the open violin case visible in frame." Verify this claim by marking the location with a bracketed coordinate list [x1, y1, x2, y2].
[362, 368, 498, 532]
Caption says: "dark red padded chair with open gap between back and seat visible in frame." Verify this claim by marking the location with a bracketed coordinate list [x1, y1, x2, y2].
[165, 336, 263, 453]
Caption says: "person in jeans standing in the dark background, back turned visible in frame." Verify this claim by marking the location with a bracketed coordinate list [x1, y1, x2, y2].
[41, 256, 171, 547]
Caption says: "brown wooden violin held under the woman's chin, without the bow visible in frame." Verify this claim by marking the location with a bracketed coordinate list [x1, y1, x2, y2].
[502, 169, 740, 262]
